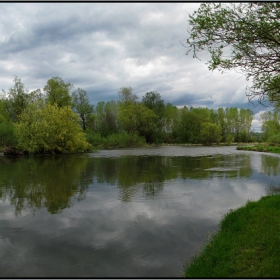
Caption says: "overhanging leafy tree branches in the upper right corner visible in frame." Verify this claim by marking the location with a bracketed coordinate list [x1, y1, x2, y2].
[185, 2, 280, 103]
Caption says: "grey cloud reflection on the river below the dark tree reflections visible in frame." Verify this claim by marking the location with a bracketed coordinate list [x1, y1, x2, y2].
[0, 167, 268, 277]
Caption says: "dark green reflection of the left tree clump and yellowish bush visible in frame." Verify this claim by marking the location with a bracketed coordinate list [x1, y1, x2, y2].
[0, 155, 92, 215]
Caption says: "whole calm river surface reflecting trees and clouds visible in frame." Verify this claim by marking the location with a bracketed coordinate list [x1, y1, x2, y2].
[0, 146, 280, 277]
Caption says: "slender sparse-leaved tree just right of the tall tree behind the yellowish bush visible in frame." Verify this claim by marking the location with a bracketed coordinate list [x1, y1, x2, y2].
[72, 88, 94, 130]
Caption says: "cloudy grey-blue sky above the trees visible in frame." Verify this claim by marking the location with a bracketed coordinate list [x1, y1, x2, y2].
[0, 2, 267, 132]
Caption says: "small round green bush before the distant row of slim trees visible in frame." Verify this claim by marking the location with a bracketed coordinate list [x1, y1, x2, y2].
[200, 122, 222, 145]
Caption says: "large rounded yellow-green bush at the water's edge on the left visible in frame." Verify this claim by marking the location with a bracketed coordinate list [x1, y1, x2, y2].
[15, 102, 88, 153]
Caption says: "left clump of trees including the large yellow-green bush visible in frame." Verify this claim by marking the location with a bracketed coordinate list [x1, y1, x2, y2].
[0, 77, 89, 153]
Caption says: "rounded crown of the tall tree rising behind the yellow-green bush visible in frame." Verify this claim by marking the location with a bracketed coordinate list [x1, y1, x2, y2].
[44, 77, 73, 107]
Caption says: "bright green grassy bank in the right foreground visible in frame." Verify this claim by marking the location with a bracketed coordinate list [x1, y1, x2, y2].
[183, 195, 280, 278]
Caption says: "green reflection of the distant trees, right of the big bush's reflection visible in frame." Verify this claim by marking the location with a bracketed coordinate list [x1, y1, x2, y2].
[93, 155, 252, 202]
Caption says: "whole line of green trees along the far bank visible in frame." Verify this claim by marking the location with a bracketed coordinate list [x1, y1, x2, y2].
[0, 76, 254, 153]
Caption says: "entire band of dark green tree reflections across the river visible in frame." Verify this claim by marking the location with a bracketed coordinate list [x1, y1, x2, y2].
[0, 154, 255, 211]
